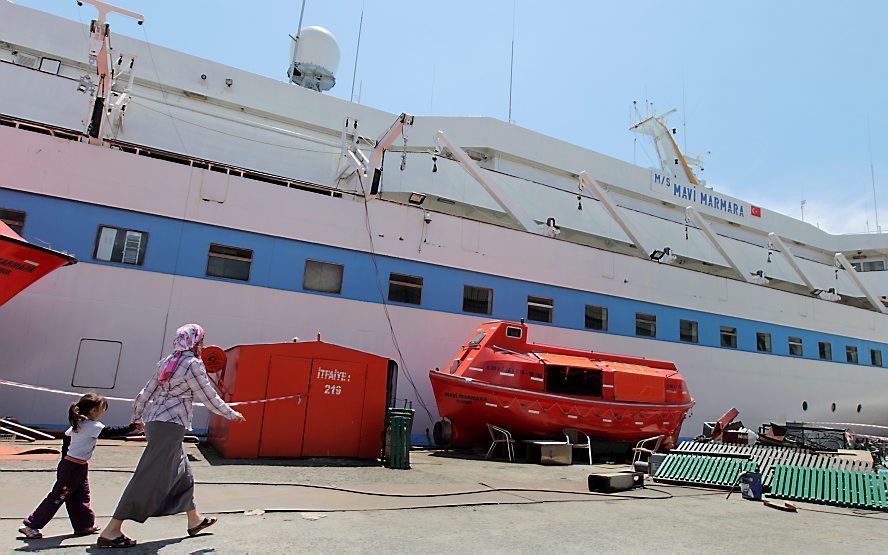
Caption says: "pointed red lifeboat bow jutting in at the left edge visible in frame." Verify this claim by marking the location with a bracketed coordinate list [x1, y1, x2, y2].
[0, 222, 77, 306]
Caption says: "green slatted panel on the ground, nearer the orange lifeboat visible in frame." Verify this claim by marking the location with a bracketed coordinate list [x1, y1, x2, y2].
[654, 454, 758, 488]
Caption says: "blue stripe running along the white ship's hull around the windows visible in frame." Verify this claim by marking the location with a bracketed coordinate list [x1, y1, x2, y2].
[0, 187, 888, 365]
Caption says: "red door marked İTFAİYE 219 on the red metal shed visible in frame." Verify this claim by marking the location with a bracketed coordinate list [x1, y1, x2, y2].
[302, 359, 367, 457]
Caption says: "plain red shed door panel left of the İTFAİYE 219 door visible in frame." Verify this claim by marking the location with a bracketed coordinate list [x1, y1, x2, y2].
[259, 356, 312, 457]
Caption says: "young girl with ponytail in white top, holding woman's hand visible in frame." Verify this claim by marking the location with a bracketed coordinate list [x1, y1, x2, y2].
[19, 393, 139, 539]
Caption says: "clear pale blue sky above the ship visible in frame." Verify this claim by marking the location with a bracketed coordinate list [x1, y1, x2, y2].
[16, 0, 888, 233]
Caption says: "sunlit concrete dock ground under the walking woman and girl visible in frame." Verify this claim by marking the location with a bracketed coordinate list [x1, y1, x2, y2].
[0, 440, 888, 553]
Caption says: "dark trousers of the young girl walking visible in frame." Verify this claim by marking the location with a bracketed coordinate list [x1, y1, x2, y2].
[24, 458, 96, 532]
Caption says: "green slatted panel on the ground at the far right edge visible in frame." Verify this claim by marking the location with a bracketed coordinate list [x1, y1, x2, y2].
[768, 465, 888, 511]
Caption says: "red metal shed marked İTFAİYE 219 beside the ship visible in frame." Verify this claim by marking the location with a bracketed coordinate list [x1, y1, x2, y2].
[209, 339, 398, 459]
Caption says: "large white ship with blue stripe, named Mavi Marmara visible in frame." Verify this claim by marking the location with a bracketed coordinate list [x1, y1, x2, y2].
[0, 0, 888, 443]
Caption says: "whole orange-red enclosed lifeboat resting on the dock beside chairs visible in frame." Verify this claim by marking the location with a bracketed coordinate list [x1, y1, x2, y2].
[429, 321, 694, 446]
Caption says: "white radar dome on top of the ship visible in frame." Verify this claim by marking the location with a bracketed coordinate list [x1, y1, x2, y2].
[287, 26, 339, 91]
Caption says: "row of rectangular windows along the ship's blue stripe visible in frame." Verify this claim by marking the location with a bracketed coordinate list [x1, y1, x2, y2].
[0, 209, 882, 366]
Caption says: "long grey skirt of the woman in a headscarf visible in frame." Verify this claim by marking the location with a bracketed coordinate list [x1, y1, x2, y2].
[114, 422, 194, 522]
